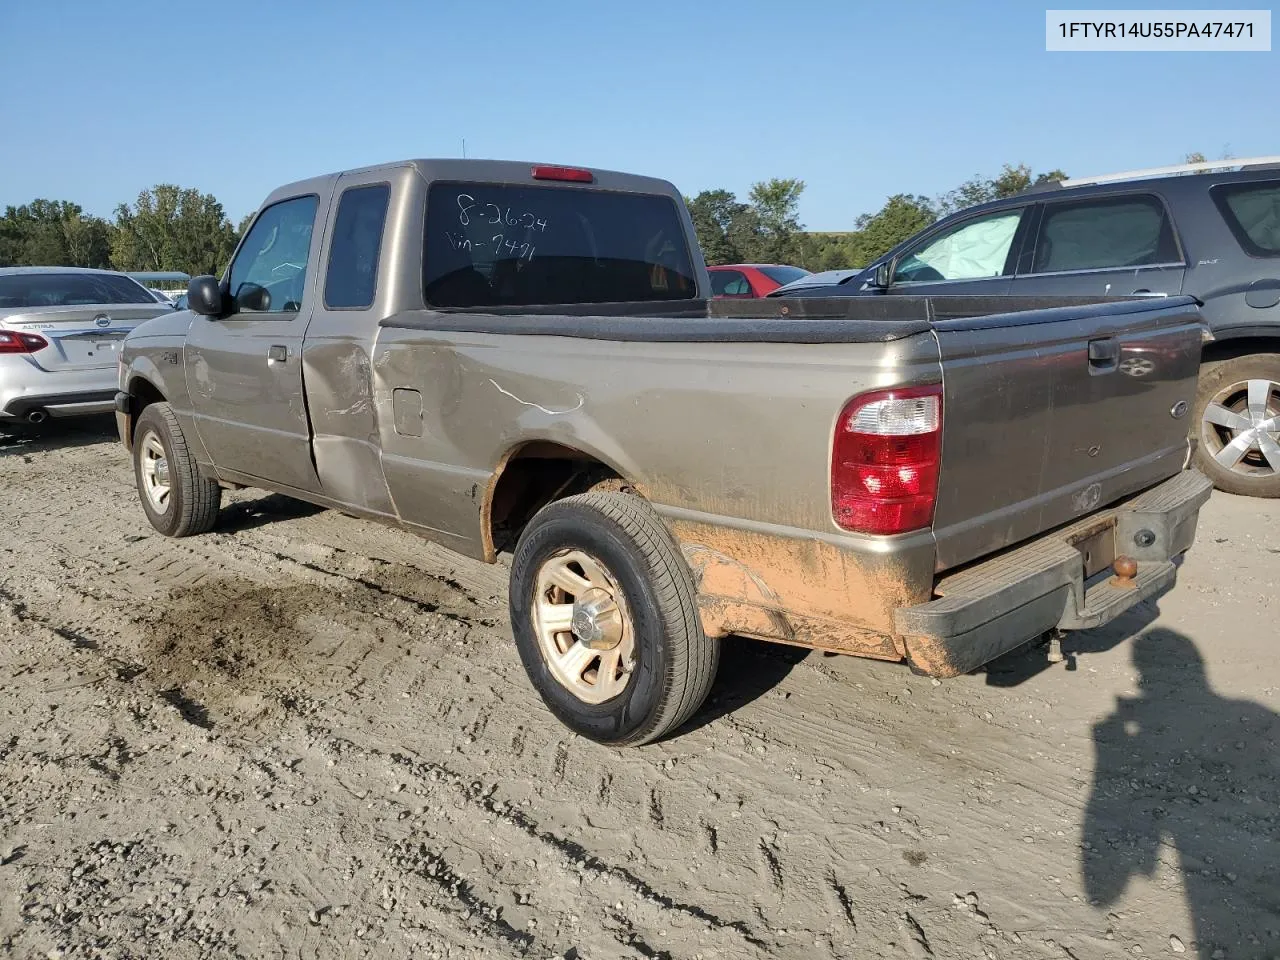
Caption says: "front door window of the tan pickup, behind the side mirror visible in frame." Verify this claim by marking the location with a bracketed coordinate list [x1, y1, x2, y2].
[230, 196, 320, 314]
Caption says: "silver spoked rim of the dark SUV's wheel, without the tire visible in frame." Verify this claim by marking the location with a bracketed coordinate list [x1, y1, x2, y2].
[1201, 379, 1280, 479]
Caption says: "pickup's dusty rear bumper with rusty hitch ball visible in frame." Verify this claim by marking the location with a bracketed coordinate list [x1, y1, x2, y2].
[895, 471, 1212, 677]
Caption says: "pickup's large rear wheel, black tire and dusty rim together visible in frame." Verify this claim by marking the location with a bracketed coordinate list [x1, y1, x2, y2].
[509, 492, 719, 746]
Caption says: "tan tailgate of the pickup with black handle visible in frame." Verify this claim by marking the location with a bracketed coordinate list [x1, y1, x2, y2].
[933, 297, 1203, 570]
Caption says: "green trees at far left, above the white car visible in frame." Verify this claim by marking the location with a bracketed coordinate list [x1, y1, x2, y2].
[0, 183, 248, 276]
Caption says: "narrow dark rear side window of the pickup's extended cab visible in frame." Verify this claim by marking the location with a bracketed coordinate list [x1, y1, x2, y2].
[324, 183, 392, 310]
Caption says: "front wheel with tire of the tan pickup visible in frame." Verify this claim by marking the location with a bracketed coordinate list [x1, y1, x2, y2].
[133, 403, 223, 536]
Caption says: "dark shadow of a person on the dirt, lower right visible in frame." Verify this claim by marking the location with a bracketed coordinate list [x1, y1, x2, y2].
[1083, 628, 1280, 960]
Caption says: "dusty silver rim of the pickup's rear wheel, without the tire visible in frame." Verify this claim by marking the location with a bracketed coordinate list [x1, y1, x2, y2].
[532, 550, 635, 704]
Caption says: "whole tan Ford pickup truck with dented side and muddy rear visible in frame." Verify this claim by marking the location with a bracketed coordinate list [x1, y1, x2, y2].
[116, 160, 1210, 744]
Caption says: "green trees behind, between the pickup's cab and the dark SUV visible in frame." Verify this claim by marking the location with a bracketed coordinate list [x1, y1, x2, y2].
[685, 164, 1066, 271]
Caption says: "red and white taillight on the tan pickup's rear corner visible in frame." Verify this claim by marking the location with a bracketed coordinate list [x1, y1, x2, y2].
[831, 387, 942, 534]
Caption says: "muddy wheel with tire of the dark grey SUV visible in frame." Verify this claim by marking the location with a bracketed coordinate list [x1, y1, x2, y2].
[1194, 353, 1280, 497]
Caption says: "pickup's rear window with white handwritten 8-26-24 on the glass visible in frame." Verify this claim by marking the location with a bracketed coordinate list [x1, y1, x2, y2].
[422, 183, 698, 307]
